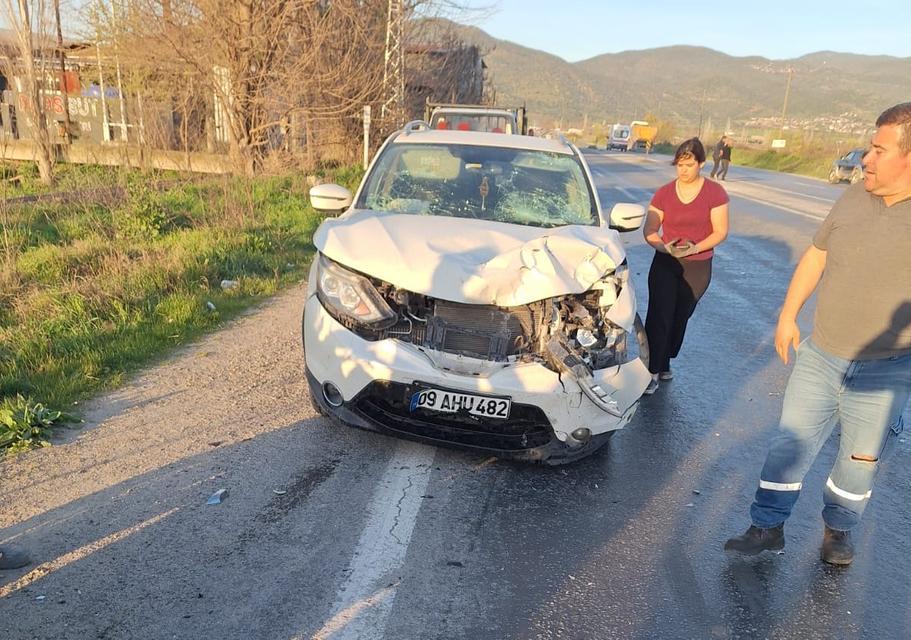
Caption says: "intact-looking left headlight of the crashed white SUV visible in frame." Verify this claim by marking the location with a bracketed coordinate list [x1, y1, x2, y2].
[316, 255, 397, 324]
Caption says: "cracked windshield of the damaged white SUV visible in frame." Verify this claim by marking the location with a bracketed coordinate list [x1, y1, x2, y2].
[357, 144, 598, 227]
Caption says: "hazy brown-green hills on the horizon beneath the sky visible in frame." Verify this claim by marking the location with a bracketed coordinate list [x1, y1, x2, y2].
[436, 24, 911, 131]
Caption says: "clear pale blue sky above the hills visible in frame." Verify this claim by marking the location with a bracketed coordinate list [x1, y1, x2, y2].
[456, 0, 911, 62]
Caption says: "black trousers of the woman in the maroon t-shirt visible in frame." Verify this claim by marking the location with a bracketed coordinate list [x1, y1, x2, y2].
[645, 251, 712, 373]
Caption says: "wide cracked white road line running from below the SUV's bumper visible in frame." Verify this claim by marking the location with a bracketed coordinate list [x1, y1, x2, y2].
[310, 441, 436, 640]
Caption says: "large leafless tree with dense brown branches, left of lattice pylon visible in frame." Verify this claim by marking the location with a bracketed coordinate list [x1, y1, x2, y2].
[85, 0, 385, 174]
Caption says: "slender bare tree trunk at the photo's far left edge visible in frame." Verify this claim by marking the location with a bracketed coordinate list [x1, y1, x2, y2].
[2, 0, 54, 185]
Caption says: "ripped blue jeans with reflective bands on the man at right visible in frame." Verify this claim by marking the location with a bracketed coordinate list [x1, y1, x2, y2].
[750, 340, 911, 531]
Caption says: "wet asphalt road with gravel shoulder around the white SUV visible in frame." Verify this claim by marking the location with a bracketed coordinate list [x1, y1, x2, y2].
[0, 152, 911, 640]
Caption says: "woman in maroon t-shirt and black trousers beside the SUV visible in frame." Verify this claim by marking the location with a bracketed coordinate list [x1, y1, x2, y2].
[643, 138, 728, 394]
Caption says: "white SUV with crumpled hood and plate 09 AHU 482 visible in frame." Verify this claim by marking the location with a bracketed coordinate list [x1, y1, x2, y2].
[303, 123, 650, 464]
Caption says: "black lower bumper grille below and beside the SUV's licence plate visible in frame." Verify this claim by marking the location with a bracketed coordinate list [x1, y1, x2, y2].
[354, 380, 553, 451]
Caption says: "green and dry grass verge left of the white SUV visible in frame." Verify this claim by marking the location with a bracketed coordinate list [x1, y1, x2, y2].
[0, 170, 361, 448]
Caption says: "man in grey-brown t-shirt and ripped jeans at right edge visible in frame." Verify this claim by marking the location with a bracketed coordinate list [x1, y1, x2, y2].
[724, 102, 911, 565]
